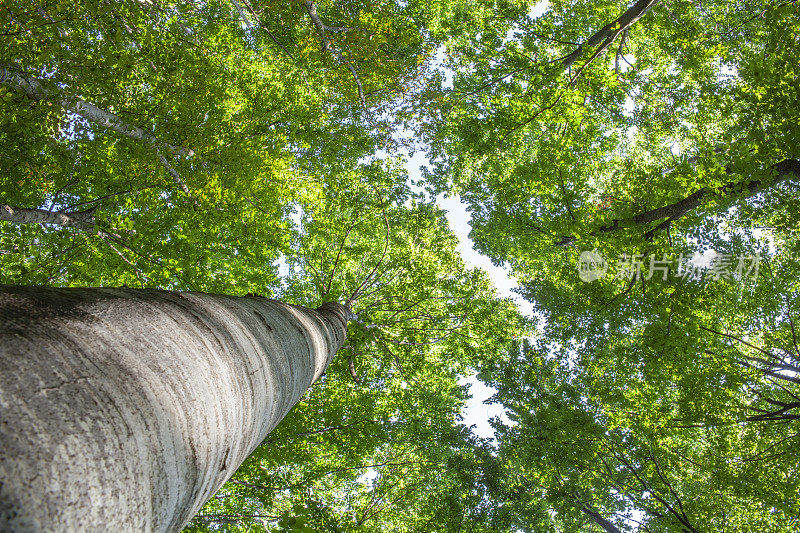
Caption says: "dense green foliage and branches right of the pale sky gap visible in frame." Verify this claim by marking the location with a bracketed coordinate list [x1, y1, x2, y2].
[426, 1, 800, 531]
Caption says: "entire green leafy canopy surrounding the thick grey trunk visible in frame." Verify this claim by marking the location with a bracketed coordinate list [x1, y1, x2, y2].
[0, 0, 800, 533]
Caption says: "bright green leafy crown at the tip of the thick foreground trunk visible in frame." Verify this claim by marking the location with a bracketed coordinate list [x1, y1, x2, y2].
[181, 165, 525, 532]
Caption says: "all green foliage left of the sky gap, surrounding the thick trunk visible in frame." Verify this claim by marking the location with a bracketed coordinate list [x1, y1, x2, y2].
[0, 1, 523, 531]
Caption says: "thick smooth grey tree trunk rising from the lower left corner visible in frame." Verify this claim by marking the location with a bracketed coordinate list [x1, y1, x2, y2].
[0, 287, 351, 532]
